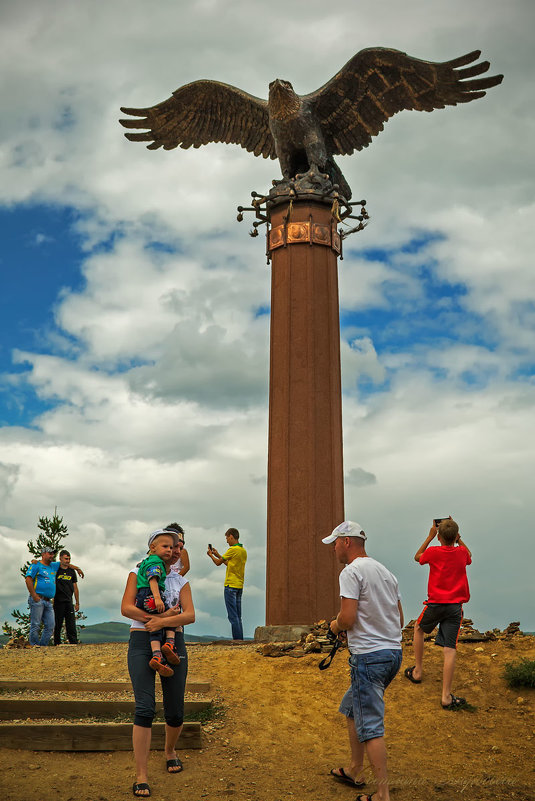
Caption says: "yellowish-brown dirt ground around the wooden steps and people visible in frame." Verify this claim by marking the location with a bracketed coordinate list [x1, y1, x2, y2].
[0, 637, 535, 801]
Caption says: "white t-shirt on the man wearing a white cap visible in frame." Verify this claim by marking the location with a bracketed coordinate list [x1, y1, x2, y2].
[340, 556, 401, 654]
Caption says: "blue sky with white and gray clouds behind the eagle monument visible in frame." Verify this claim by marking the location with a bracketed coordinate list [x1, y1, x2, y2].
[0, 0, 535, 634]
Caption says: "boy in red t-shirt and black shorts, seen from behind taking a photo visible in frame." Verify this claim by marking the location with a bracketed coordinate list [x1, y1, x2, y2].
[405, 517, 472, 710]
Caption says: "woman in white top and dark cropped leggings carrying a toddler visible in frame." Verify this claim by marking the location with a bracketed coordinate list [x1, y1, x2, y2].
[121, 529, 195, 798]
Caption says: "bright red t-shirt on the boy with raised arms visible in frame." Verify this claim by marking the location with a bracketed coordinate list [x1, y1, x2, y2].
[420, 545, 472, 604]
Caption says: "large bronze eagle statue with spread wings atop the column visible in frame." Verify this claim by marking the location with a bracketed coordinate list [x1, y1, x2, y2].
[120, 47, 503, 200]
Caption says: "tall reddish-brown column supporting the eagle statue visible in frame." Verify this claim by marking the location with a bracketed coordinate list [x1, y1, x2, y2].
[266, 199, 344, 625]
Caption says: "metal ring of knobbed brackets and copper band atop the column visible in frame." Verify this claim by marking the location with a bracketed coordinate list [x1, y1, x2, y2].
[237, 181, 369, 264]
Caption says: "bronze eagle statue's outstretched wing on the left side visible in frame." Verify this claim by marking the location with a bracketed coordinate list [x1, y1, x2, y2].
[120, 81, 277, 159]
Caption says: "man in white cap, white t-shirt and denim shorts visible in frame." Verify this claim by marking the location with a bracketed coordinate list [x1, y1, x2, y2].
[322, 520, 403, 801]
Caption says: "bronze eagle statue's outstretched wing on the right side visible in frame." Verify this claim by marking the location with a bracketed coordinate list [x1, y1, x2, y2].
[303, 47, 503, 155]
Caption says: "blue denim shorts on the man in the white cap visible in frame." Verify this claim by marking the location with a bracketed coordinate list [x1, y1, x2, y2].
[339, 648, 401, 743]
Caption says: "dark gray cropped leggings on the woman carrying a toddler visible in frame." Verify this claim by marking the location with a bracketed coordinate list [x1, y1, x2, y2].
[128, 629, 188, 729]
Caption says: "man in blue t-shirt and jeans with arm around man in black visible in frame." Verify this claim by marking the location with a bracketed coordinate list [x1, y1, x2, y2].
[25, 546, 84, 645]
